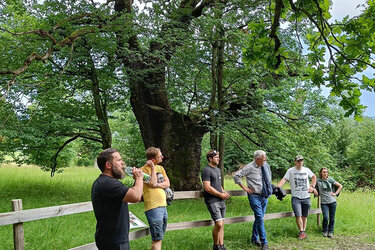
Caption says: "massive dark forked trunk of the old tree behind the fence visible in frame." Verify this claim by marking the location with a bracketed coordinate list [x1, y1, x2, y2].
[115, 0, 210, 190]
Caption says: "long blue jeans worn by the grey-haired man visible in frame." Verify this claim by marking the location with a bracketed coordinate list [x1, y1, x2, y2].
[247, 194, 268, 244]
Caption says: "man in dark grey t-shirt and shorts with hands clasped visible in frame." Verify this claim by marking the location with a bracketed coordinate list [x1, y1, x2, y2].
[201, 150, 229, 250]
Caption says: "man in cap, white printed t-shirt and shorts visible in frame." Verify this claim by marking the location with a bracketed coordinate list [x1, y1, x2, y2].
[277, 155, 318, 240]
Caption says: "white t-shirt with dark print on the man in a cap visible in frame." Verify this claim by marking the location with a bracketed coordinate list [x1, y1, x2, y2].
[284, 167, 314, 199]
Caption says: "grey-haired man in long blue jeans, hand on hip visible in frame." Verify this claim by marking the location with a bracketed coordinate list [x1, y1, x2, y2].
[233, 150, 272, 249]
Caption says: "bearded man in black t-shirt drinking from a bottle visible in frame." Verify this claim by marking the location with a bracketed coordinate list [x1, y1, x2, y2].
[91, 148, 143, 250]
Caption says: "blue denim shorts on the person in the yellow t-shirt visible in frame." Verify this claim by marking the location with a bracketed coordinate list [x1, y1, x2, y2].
[145, 207, 168, 241]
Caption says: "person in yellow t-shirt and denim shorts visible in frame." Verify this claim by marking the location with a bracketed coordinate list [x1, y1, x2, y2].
[141, 147, 170, 250]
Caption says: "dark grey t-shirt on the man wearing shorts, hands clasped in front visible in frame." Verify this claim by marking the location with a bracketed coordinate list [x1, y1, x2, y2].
[201, 165, 223, 204]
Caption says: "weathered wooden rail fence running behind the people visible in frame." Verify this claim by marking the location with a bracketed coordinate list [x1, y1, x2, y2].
[0, 189, 321, 250]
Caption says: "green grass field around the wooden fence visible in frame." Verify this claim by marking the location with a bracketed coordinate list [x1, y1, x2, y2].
[0, 166, 375, 250]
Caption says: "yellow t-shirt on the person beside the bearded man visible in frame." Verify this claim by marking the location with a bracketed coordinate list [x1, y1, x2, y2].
[141, 165, 167, 211]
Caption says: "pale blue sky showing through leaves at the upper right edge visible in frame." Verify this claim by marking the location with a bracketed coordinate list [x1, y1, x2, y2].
[331, 0, 375, 117]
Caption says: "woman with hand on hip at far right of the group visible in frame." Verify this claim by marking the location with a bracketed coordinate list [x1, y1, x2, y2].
[317, 168, 342, 238]
